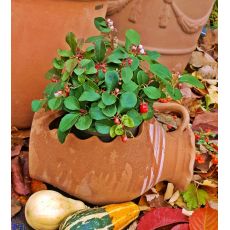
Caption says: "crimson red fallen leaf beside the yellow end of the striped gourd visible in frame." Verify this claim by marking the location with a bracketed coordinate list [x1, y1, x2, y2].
[137, 207, 188, 230]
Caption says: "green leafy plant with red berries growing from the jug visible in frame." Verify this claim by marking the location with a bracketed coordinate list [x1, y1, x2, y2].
[32, 17, 203, 143]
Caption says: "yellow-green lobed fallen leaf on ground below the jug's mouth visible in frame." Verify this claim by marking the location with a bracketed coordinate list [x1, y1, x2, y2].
[182, 184, 208, 210]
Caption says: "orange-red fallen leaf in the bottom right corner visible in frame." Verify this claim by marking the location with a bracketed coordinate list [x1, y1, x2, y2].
[189, 206, 218, 230]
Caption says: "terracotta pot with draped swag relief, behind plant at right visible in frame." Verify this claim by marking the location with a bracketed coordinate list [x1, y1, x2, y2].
[107, 0, 215, 72]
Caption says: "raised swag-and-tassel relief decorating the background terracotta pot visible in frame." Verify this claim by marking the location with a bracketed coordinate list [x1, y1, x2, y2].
[107, 0, 212, 34]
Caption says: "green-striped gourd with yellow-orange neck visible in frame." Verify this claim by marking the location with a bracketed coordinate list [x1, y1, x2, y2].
[59, 202, 140, 230]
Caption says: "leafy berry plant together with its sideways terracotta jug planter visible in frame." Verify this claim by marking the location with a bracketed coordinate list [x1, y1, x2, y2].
[29, 17, 203, 204]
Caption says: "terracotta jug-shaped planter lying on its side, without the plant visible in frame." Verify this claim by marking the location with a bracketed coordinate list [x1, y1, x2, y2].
[29, 103, 195, 204]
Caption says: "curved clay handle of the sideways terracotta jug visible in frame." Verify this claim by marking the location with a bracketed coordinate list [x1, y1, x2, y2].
[153, 102, 190, 131]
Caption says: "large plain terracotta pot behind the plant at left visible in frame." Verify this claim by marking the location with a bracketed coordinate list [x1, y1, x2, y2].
[11, 0, 107, 128]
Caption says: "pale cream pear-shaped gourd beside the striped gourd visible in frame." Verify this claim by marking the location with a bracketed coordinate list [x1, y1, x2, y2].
[25, 190, 87, 230]
